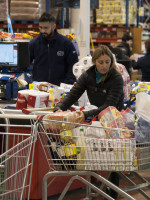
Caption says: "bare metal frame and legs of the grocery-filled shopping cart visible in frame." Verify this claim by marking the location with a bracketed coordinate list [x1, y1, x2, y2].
[38, 120, 150, 200]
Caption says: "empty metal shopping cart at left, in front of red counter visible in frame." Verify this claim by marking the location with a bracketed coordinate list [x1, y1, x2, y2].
[0, 110, 37, 200]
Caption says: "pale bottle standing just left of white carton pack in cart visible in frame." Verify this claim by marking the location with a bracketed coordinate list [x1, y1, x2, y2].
[76, 128, 86, 170]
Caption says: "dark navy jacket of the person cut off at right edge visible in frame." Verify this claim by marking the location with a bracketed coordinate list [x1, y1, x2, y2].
[132, 52, 150, 82]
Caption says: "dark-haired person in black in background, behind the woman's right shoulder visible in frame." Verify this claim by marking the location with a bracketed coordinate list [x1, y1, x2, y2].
[117, 33, 133, 57]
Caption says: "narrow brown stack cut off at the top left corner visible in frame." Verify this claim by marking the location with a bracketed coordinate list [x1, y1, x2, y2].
[0, 0, 8, 21]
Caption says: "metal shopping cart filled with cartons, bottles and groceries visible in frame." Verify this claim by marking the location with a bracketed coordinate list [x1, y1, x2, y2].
[38, 120, 150, 200]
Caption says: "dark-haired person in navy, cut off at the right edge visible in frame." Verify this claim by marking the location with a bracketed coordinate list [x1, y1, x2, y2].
[130, 39, 150, 82]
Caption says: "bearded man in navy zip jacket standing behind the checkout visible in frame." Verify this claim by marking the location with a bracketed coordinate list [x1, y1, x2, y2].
[29, 12, 78, 85]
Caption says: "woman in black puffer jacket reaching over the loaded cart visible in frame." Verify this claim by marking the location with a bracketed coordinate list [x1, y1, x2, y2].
[54, 45, 124, 199]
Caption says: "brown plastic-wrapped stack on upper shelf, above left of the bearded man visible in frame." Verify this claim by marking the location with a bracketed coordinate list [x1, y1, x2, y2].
[10, 0, 39, 20]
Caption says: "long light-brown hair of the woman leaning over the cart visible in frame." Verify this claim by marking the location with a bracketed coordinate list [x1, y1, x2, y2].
[92, 45, 116, 69]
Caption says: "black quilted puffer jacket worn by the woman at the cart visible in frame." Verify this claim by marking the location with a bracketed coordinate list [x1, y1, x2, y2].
[54, 66, 124, 118]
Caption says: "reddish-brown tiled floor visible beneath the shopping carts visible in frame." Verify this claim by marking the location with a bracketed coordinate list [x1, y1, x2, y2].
[48, 169, 150, 200]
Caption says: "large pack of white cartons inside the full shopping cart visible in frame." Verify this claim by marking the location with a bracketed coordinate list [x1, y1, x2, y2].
[85, 138, 137, 171]
